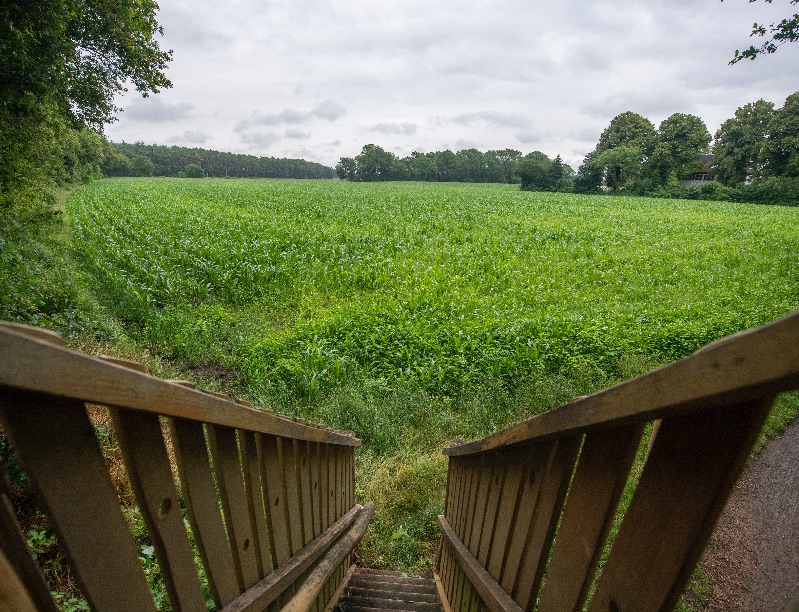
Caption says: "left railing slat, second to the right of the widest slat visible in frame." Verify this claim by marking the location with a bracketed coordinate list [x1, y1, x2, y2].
[167, 419, 239, 607]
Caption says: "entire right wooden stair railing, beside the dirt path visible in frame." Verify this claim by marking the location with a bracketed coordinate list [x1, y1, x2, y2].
[438, 313, 799, 612]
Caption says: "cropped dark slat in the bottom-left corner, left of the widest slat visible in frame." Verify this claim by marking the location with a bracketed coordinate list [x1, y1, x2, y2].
[0, 460, 58, 612]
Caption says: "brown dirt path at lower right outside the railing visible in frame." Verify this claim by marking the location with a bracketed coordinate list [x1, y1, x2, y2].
[700, 420, 799, 612]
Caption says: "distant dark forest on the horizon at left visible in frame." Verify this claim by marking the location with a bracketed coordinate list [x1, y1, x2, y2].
[106, 142, 336, 179]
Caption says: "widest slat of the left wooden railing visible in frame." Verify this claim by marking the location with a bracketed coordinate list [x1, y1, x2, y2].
[0, 394, 155, 610]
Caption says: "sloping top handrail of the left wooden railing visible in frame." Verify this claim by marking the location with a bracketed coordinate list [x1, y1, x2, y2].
[0, 327, 360, 446]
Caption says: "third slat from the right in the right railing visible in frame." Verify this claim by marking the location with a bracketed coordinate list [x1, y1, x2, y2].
[515, 436, 582, 608]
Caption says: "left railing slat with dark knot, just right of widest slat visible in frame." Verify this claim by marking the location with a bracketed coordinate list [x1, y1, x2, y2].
[111, 408, 205, 610]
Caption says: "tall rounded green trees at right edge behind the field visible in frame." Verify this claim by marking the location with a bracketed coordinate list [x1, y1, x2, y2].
[574, 92, 799, 205]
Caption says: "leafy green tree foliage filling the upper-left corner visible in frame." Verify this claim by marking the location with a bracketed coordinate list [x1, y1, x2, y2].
[0, 0, 171, 208]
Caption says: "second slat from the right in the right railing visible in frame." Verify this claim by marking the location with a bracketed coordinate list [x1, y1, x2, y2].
[536, 424, 643, 612]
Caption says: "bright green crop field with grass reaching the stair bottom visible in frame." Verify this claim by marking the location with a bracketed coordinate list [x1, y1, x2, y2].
[67, 179, 799, 566]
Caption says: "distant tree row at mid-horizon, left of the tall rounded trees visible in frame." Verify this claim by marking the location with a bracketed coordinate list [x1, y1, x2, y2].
[336, 144, 574, 189]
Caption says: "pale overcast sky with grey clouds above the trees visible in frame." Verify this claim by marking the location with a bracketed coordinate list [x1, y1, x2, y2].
[105, 0, 799, 169]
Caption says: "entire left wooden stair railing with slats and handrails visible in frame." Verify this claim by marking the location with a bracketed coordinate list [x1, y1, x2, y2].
[0, 324, 373, 610]
